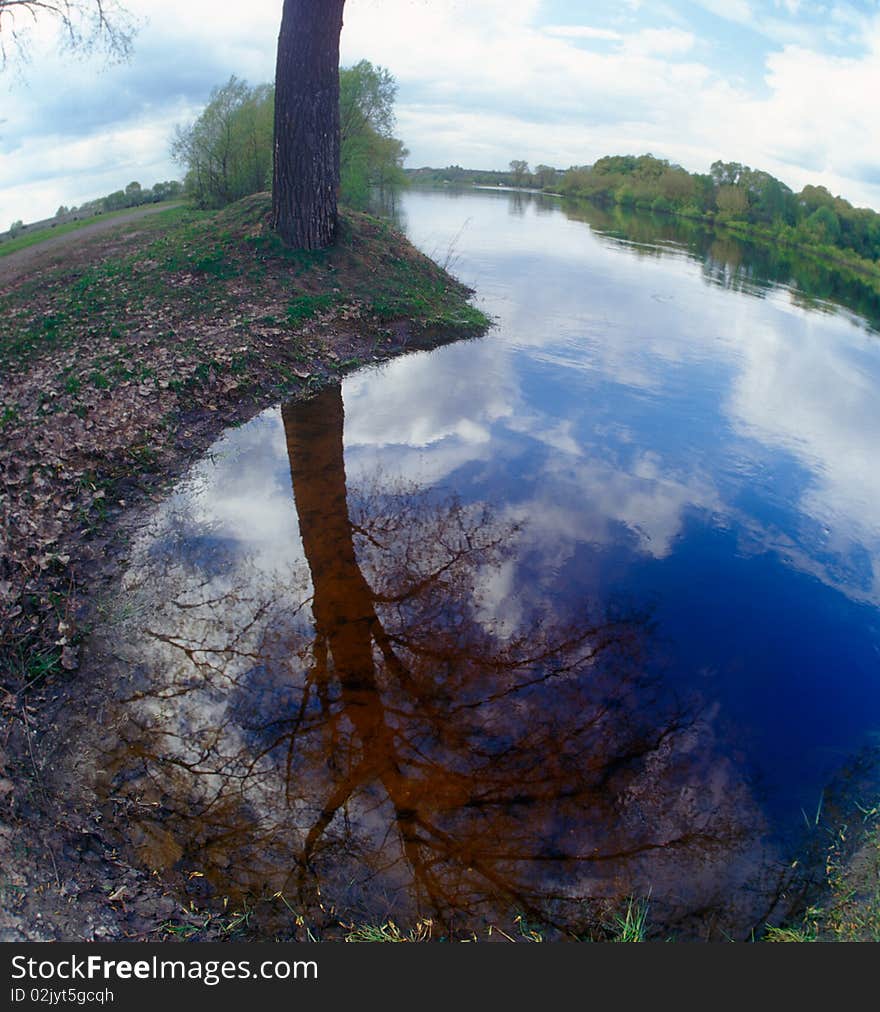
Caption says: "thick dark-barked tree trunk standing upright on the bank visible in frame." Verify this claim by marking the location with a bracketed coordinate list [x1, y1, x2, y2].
[272, 0, 345, 250]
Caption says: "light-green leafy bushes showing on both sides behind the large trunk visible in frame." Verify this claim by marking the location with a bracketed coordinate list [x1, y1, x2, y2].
[171, 60, 408, 208]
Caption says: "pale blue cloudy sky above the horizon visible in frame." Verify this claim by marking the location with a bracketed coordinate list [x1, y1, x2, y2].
[0, 0, 880, 225]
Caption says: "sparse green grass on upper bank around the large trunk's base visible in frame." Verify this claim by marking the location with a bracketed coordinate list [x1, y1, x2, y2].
[0, 198, 489, 380]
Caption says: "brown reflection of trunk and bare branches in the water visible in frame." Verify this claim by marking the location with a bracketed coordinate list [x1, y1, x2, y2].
[91, 387, 775, 936]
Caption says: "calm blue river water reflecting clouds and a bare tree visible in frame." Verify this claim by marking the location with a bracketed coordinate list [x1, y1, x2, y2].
[75, 192, 880, 937]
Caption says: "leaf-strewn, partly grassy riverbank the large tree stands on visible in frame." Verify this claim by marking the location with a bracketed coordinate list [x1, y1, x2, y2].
[0, 194, 489, 941]
